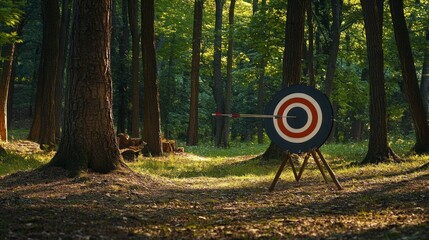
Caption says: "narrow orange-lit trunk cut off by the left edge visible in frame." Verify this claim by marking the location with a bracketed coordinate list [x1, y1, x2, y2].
[0, 43, 15, 142]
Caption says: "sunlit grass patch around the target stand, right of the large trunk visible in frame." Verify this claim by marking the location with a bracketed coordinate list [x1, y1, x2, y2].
[129, 140, 429, 188]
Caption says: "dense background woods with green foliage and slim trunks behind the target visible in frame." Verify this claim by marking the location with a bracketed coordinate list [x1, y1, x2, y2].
[0, 0, 429, 167]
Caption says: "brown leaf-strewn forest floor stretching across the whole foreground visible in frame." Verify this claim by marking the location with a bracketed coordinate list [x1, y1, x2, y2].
[0, 141, 429, 239]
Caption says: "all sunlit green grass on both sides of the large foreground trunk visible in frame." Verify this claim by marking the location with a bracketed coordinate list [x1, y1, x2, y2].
[0, 138, 429, 185]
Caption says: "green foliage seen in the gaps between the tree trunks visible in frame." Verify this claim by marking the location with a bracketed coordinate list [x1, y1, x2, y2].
[0, 0, 429, 148]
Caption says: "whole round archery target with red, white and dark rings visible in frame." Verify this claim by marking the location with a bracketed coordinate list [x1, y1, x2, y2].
[264, 85, 333, 153]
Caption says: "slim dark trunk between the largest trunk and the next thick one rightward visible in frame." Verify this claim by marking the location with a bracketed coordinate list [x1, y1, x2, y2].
[128, 0, 140, 138]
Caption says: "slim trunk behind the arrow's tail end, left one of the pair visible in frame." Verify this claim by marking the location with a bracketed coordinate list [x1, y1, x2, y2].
[213, 0, 227, 147]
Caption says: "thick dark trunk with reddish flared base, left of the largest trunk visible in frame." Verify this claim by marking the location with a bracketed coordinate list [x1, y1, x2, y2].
[28, 0, 60, 148]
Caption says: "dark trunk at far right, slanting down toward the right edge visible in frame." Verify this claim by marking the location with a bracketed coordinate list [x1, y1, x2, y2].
[389, 0, 429, 154]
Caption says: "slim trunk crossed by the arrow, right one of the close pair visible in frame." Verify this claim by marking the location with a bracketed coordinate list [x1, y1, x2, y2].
[222, 0, 235, 146]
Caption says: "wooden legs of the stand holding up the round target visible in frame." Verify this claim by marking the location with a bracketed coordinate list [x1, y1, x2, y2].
[268, 149, 343, 192]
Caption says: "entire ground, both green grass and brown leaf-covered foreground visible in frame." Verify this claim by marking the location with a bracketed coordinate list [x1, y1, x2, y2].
[0, 140, 429, 239]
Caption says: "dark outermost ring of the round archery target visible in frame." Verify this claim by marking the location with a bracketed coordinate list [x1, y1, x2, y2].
[264, 85, 333, 153]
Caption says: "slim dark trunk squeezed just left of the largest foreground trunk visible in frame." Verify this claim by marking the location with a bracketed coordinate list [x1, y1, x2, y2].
[55, 0, 71, 139]
